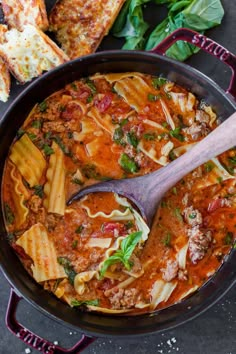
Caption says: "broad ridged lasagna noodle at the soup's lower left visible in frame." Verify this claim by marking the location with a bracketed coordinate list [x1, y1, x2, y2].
[16, 223, 67, 282]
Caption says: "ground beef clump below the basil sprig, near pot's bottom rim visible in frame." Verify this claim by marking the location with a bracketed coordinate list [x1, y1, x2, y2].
[104, 288, 139, 309]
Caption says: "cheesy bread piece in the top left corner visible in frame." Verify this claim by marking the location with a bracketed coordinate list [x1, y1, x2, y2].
[1, 0, 48, 31]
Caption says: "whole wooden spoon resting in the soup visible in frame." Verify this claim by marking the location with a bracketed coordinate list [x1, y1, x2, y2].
[67, 112, 236, 226]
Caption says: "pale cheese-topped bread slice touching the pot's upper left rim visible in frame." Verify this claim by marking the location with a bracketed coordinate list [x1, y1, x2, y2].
[0, 25, 68, 83]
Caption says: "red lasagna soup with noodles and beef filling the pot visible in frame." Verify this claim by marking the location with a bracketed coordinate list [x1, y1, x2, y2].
[2, 73, 236, 314]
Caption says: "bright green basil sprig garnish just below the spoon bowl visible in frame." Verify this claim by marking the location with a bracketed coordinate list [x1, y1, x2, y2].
[100, 231, 142, 277]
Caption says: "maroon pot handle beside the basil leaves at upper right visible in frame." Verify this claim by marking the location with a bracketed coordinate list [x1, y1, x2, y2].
[151, 28, 236, 99]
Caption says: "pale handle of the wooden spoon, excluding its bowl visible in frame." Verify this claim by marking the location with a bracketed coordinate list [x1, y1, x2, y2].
[149, 112, 236, 193]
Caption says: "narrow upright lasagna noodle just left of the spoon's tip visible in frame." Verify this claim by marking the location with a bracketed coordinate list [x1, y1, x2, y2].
[44, 141, 65, 215]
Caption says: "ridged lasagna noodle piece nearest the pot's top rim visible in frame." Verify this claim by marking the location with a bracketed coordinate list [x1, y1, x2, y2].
[114, 76, 151, 112]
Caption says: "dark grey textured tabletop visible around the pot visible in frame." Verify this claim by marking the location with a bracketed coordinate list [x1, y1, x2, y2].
[0, 0, 236, 354]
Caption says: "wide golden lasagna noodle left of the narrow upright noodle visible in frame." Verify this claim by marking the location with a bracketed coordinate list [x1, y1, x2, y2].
[9, 134, 46, 187]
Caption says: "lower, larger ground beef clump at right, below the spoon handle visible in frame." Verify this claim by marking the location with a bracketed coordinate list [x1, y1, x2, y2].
[188, 226, 212, 264]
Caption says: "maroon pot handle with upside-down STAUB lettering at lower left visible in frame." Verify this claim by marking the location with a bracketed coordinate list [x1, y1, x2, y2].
[5, 289, 96, 354]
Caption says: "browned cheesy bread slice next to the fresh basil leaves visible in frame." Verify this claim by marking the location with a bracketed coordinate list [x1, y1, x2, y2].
[49, 0, 126, 59]
